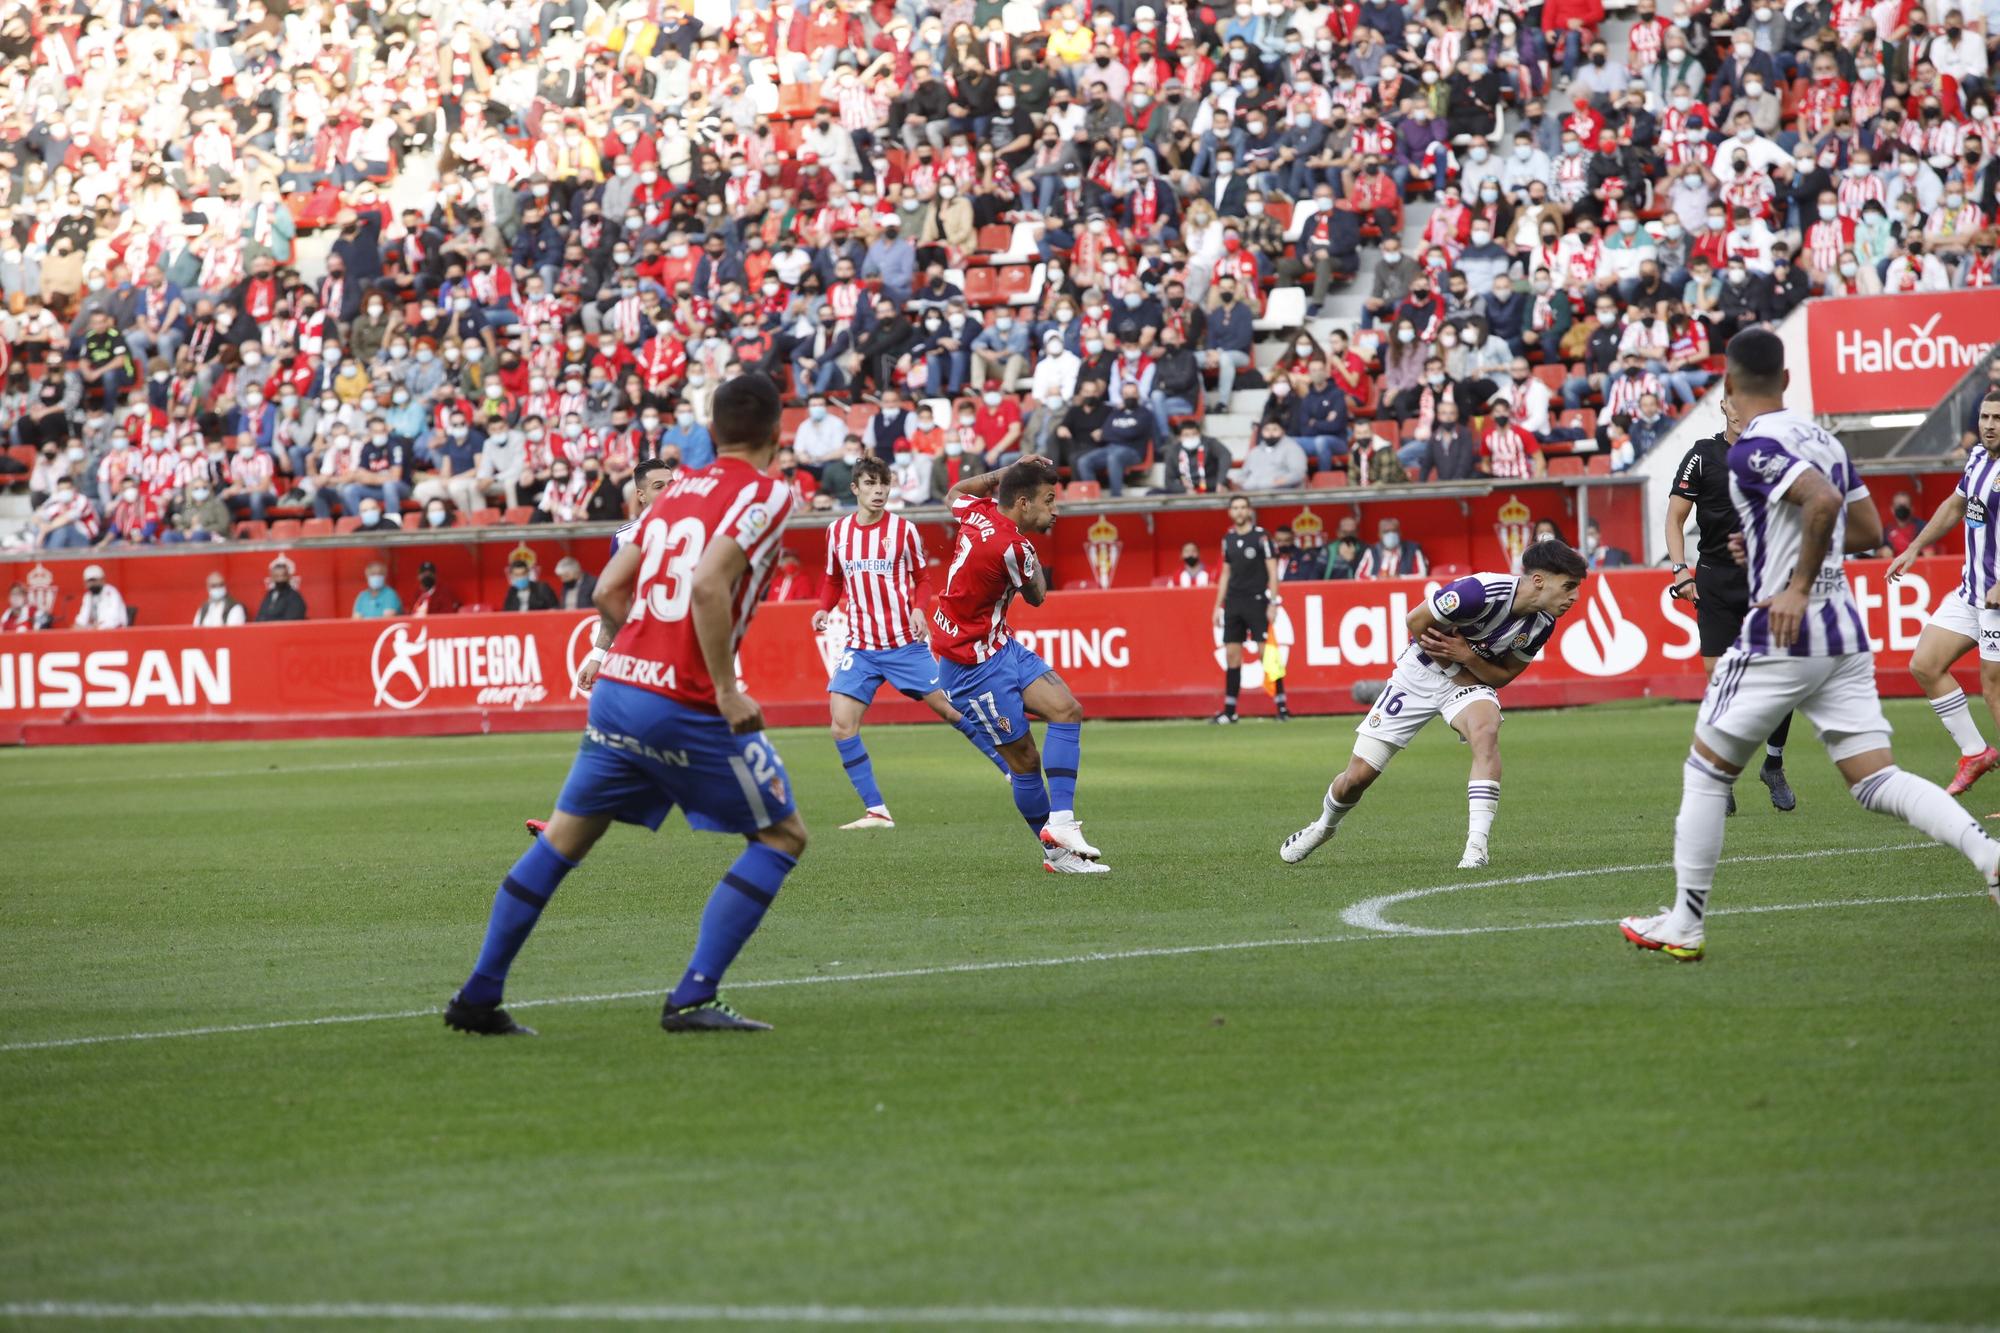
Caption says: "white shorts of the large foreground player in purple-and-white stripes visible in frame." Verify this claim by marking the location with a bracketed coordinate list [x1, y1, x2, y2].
[1700, 648, 1894, 749]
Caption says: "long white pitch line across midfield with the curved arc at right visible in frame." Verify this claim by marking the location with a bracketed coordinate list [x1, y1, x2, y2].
[0, 843, 1982, 1055]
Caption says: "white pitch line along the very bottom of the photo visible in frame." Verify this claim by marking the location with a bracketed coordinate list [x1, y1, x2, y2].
[0, 1301, 2000, 1333]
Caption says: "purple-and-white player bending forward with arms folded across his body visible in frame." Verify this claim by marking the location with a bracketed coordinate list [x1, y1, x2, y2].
[1278, 540, 1588, 869]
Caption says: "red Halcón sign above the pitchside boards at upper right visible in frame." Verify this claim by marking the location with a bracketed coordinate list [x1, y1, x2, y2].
[1806, 288, 2000, 416]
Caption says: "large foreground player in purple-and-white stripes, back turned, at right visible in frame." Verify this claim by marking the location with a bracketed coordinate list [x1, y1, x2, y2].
[1618, 328, 2000, 963]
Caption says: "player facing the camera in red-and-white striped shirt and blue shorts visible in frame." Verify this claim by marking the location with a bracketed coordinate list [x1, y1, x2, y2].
[812, 456, 1006, 831]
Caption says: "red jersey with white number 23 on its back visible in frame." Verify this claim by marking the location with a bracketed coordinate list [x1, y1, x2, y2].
[602, 456, 792, 711]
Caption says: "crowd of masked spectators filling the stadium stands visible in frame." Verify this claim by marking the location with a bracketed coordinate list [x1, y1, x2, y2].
[0, 0, 2000, 558]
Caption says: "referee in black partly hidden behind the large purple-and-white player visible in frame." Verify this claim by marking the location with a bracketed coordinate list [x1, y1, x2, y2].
[1666, 398, 1798, 815]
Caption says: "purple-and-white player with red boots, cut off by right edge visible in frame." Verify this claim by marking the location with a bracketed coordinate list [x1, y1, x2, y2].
[1888, 388, 2000, 797]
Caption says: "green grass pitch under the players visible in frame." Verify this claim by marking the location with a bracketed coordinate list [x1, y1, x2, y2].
[0, 703, 2000, 1333]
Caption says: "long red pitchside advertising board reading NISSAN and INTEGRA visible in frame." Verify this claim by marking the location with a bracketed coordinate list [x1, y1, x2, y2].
[0, 558, 1976, 745]
